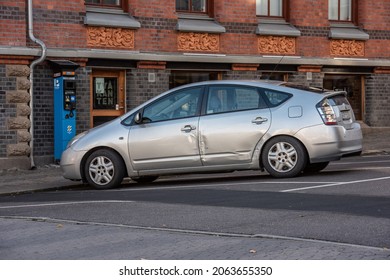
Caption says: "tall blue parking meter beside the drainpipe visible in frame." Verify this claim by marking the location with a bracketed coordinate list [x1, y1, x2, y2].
[54, 63, 78, 162]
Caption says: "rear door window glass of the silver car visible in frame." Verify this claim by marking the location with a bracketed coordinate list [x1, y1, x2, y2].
[206, 86, 267, 114]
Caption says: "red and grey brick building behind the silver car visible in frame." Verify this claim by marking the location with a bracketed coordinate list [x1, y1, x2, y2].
[0, 0, 390, 169]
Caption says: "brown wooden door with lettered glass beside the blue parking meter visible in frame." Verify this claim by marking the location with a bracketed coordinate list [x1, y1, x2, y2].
[90, 70, 125, 127]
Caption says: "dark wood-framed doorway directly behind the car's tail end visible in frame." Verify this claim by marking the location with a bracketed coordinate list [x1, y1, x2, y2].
[323, 74, 364, 120]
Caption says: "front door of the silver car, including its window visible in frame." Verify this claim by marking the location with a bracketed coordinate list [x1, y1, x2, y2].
[128, 87, 203, 172]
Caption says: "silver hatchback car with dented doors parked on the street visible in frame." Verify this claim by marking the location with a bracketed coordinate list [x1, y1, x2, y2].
[60, 80, 362, 189]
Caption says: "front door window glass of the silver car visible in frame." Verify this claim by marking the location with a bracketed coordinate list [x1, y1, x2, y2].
[143, 87, 203, 122]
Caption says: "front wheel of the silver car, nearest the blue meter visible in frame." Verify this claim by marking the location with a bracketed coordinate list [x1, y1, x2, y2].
[84, 149, 125, 189]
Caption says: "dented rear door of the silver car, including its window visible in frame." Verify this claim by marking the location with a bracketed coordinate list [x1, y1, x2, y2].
[199, 85, 271, 166]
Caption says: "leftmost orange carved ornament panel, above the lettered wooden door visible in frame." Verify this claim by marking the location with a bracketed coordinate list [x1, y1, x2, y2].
[87, 27, 134, 49]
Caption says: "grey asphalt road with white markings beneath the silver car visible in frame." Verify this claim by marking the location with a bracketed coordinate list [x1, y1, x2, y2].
[0, 156, 390, 259]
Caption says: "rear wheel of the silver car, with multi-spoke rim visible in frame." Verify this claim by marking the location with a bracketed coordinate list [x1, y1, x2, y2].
[261, 136, 307, 178]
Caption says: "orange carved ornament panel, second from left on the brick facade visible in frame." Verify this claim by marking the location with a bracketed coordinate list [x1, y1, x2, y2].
[177, 32, 219, 52]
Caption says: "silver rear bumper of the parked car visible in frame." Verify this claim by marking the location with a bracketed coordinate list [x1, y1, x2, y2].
[296, 123, 363, 163]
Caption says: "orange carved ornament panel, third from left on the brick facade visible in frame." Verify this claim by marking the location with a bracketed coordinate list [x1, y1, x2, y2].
[258, 36, 296, 54]
